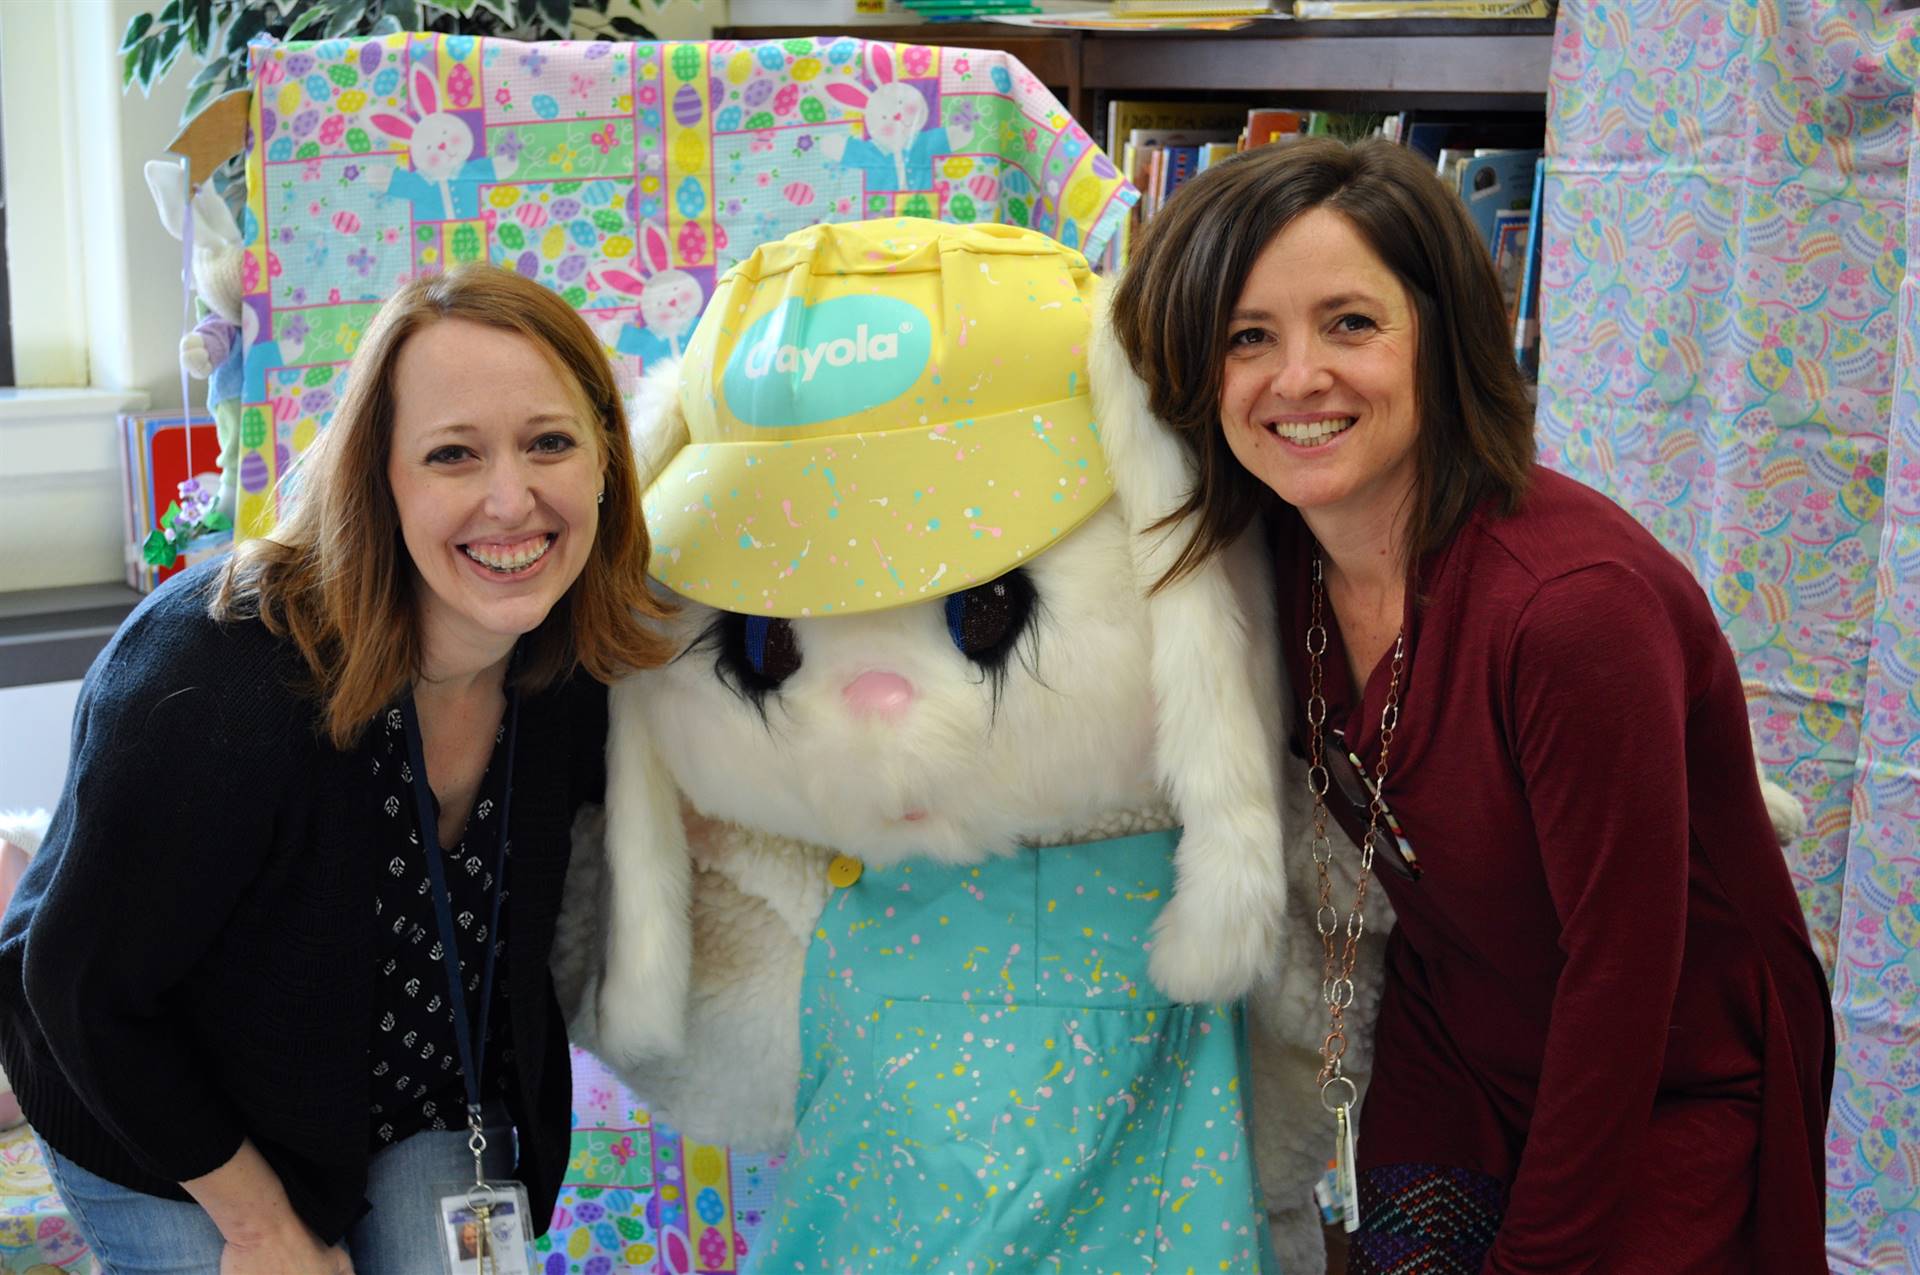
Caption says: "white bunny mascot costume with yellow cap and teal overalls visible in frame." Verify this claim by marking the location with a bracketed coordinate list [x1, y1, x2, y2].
[555, 219, 1384, 1271]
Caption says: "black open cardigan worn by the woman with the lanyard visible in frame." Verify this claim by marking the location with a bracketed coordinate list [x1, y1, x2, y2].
[0, 565, 607, 1242]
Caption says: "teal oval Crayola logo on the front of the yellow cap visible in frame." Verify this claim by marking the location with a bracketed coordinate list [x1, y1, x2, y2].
[720, 296, 933, 426]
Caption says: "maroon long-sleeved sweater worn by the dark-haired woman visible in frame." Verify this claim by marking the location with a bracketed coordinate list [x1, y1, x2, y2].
[1277, 469, 1834, 1275]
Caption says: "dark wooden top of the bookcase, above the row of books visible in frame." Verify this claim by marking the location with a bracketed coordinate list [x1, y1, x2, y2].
[714, 17, 1553, 122]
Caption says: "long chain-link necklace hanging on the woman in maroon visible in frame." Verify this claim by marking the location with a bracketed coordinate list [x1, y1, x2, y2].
[1308, 555, 1407, 1231]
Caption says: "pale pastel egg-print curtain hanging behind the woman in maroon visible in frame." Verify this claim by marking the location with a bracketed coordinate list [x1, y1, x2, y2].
[1540, 0, 1920, 1273]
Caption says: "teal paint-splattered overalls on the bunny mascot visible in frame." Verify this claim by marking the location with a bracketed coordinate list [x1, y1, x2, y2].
[756, 830, 1277, 1275]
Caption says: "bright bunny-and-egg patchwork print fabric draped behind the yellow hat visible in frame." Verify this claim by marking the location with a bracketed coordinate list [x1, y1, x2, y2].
[238, 35, 1139, 536]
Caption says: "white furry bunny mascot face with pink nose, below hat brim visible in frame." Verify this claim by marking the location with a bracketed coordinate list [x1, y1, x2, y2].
[636, 505, 1162, 864]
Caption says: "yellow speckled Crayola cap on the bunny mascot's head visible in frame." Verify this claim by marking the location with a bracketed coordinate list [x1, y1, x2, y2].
[645, 217, 1114, 618]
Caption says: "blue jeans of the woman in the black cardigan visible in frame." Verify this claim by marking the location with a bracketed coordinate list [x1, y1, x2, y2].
[40, 1104, 513, 1275]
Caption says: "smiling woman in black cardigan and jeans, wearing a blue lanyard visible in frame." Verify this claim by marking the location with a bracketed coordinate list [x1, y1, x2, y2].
[0, 267, 666, 1275]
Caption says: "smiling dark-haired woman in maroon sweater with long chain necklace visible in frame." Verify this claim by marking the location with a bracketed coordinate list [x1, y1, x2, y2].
[1114, 140, 1834, 1275]
